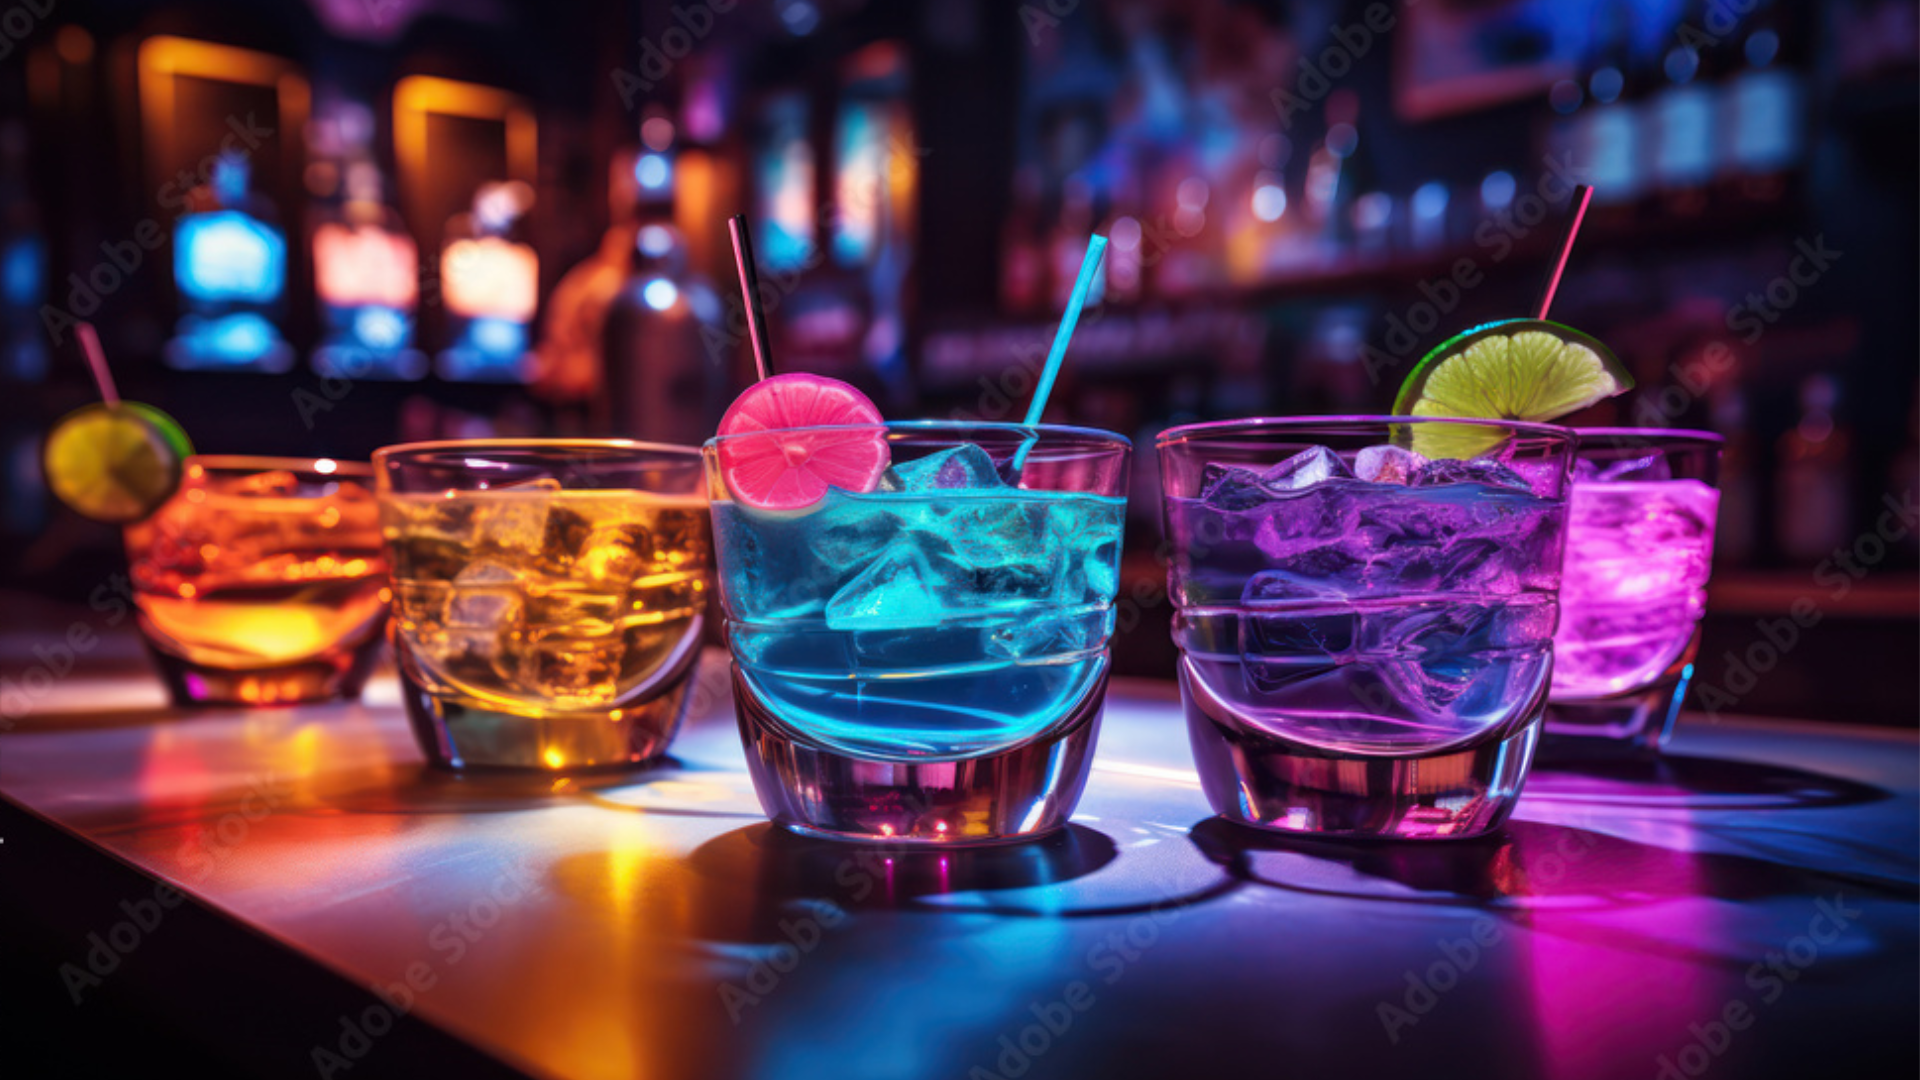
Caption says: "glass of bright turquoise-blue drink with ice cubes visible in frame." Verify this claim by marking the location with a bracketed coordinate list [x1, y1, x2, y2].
[705, 421, 1131, 844]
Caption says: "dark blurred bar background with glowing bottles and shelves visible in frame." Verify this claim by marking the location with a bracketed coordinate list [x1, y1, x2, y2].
[0, 0, 1920, 726]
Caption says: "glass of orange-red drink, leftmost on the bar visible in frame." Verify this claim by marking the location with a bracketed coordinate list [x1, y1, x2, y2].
[125, 455, 388, 705]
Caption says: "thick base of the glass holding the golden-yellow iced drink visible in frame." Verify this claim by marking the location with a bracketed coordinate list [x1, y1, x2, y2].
[399, 646, 699, 773]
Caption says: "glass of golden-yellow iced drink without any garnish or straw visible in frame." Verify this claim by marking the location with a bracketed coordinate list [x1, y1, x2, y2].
[374, 440, 710, 771]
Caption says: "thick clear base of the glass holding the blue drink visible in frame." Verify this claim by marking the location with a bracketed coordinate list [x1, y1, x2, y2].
[733, 663, 1106, 846]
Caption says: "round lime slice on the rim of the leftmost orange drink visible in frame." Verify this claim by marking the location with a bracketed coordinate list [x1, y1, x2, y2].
[40, 402, 194, 525]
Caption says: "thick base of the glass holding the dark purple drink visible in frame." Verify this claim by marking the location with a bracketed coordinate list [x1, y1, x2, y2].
[1181, 661, 1546, 840]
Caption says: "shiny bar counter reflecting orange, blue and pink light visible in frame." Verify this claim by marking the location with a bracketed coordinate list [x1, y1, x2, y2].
[0, 655, 1920, 1080]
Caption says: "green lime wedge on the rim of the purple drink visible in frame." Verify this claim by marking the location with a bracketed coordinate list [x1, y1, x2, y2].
[1394, 319, 1634, 457]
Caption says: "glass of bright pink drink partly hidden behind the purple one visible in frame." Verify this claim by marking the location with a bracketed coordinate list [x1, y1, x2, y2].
[1546, 429, 1722, 748]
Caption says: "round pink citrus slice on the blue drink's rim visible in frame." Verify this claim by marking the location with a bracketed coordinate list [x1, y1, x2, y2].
[716, 375, 891, 509]
